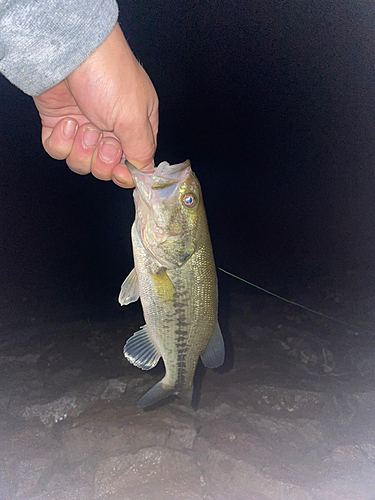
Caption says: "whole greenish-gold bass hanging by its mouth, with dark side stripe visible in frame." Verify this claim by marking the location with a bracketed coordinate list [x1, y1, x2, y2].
[118, 160, 225, 408]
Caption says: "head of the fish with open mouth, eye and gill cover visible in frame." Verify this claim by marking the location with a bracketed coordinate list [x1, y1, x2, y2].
[125, 160, 204, 269]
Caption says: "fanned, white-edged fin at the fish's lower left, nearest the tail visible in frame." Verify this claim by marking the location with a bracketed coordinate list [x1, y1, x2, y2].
[124, 325, 160, 370]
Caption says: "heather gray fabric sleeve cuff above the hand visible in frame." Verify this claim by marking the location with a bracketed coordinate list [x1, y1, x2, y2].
[0, 0, 118, 95]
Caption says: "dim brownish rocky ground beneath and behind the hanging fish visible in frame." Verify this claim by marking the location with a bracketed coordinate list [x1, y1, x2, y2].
[0, 276, 375, 500]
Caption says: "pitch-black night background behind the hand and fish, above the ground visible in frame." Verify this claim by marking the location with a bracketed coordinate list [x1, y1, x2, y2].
[0, 0, 375, 318]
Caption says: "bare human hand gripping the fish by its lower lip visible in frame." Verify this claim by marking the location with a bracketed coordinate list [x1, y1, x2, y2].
[34, 24, 158, 187]
